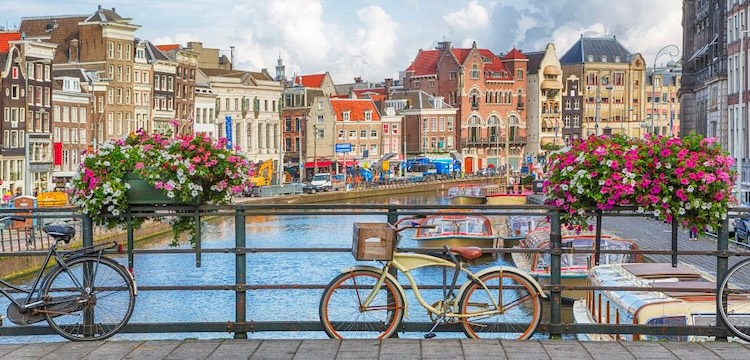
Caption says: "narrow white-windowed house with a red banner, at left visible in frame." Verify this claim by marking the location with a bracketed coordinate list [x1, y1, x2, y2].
[52, 69, 92, 171]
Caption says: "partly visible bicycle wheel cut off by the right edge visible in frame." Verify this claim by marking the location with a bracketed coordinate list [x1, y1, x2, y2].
[717, 259, 750, 341]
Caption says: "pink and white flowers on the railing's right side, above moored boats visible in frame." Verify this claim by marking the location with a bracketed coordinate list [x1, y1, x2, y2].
[545, 134, 736, 233]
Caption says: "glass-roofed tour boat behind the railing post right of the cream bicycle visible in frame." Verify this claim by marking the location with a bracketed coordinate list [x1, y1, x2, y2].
[511, 226, 641, 303]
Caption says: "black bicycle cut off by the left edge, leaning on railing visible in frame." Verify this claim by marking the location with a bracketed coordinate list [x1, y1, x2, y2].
[0, 216, 138, 341]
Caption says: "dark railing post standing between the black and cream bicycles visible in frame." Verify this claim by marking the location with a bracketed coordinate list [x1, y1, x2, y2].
[234, 205, 247, 339]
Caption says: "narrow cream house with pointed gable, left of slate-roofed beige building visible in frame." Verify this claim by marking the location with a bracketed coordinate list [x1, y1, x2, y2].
[525, 43, 570, 157]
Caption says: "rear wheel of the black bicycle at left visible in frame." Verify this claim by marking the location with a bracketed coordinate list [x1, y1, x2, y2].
[42, 256, 135, 341]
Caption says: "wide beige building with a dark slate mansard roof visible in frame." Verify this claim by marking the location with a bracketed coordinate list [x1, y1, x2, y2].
[560, 36, 649, 140]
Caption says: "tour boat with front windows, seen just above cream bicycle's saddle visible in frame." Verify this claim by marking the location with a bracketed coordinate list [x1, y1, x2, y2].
[414, 214, 498, 248]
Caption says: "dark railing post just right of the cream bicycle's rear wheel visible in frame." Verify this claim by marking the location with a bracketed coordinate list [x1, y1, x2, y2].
[549, 209, 562, 339]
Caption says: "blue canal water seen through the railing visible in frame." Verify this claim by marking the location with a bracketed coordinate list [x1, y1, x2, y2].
[0, 192, 568, 343]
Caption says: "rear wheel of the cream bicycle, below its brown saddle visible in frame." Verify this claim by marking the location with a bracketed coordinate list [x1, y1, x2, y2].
[459, 271, 542, 340]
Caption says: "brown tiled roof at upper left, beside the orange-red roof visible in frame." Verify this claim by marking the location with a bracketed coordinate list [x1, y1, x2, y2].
[18, 15, 86, 64]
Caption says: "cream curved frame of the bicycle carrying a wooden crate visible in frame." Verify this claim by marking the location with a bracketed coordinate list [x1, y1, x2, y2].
[362, 252, 499, 318]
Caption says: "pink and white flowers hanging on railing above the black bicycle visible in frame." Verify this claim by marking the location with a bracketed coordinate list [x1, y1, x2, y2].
[71, 130, 252, 244]
